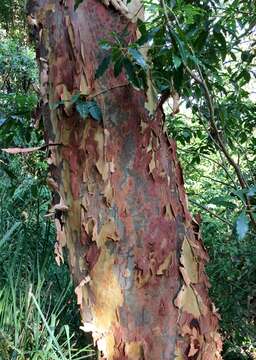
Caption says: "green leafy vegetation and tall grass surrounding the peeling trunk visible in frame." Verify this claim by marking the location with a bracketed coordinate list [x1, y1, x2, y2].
[0, 0, 256, 360]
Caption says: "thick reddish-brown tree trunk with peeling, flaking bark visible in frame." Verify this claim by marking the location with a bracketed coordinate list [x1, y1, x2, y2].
[28, 0, 221, 360]
